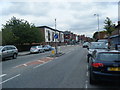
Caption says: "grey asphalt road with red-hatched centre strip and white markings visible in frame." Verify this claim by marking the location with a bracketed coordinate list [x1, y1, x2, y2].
[0, 45, 120, 88]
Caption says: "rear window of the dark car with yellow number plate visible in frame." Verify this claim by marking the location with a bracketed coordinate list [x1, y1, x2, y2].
[96, 53, 120, 61]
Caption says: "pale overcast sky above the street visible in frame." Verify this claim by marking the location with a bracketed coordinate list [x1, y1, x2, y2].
[0, 0, 119, 37]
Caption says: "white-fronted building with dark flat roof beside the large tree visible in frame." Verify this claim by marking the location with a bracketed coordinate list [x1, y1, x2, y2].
[37, 26, 64, 46]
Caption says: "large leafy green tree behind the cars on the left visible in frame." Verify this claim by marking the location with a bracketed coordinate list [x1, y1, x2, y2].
[2, 17, 43, 45]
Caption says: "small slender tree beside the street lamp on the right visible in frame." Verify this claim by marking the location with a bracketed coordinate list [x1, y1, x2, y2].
[104, 17, 115, 36]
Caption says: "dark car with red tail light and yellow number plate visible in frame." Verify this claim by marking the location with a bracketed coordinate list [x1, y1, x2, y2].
[89, 50, 120, 84]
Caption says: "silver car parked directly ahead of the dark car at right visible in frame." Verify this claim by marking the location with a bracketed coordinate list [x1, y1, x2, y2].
[87, 42, 108, 62]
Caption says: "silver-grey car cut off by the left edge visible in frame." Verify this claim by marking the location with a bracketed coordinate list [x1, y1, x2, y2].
[0, 45, 18, 60]
